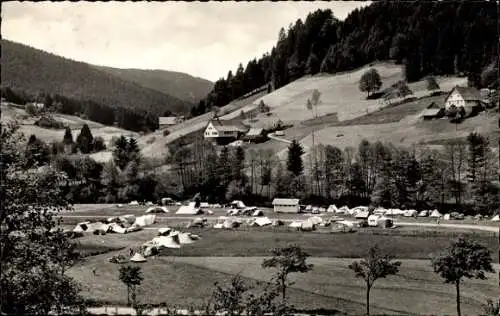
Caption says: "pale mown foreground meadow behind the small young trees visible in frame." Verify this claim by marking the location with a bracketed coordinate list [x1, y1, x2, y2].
[70, 255, 498, 315]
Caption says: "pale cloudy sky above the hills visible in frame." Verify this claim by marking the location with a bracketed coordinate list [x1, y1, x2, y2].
[1, 1, 369, 81]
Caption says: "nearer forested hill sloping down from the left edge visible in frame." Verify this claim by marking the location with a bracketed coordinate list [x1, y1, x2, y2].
[1, 40, 192, 114]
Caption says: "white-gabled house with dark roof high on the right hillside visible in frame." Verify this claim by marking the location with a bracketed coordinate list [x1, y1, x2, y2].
[444, 86, 482, 116]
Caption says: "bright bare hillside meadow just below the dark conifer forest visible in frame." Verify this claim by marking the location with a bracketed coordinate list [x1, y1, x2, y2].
[237, 63, 467, 122]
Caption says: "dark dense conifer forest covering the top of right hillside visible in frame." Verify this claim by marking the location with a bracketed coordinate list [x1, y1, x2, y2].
[191, 1, 498, 116]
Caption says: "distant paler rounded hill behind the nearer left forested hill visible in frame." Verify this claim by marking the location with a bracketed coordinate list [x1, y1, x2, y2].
[98, 67, 214, 103]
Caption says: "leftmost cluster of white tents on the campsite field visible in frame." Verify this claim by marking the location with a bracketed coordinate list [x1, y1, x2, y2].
[73, 215, 156, 234]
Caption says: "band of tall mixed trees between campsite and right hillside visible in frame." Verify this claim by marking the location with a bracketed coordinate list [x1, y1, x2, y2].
[170, 133, 500, 215]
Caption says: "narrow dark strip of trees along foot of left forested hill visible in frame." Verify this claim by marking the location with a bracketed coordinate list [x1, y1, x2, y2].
[1, 87, 159, 132]
